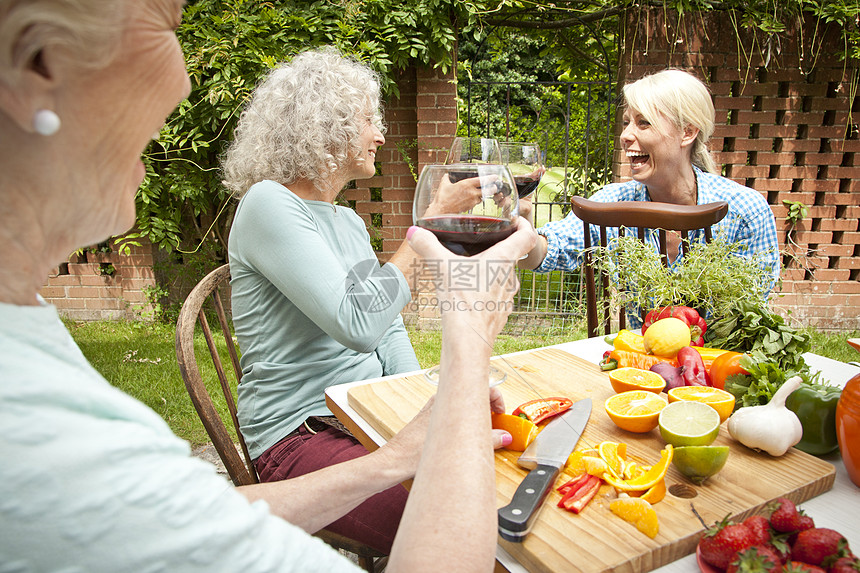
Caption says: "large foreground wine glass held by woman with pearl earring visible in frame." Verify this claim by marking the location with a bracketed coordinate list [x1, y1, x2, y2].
[412, 163, 519, 386]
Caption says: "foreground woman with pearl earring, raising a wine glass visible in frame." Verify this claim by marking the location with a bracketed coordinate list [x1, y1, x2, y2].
[0, 0, 534, 573]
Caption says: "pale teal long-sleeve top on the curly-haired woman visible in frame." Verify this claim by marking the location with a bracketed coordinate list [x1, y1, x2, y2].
[228, 181, 419, 458]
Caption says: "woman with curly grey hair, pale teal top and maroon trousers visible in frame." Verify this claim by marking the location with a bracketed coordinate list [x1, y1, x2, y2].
[223, 48, 509, 553]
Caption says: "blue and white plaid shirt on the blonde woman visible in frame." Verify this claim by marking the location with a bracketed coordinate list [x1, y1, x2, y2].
[535, 166, 780, 326]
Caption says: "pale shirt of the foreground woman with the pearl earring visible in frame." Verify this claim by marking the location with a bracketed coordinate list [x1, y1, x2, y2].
[0, 303, 358, 573]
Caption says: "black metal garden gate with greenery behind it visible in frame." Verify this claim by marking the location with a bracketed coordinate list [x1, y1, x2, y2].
[458, 77, 615, 334]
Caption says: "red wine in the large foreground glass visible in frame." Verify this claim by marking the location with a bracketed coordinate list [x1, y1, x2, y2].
[418, 215, 514, 256]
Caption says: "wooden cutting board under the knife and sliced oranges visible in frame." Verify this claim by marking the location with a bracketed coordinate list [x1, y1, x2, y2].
[348, 348, 836, 573]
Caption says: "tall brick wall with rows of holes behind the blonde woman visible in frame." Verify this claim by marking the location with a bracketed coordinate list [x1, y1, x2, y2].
[613, 9, 860, 330]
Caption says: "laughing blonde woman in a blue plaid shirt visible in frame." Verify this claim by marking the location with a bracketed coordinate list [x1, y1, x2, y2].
[519, 69, 779, 326]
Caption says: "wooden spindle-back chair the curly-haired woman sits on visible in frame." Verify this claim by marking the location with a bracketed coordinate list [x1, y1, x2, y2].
[176, 265, 385, 572]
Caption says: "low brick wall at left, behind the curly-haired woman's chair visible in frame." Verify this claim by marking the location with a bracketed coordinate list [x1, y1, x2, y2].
[40, 236, 156, 320]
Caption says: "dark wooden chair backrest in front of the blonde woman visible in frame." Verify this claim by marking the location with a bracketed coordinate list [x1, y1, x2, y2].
[570, 197, 729, 336]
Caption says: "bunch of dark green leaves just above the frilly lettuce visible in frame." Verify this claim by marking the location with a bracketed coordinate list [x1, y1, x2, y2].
[705, 300, 812, 372]
